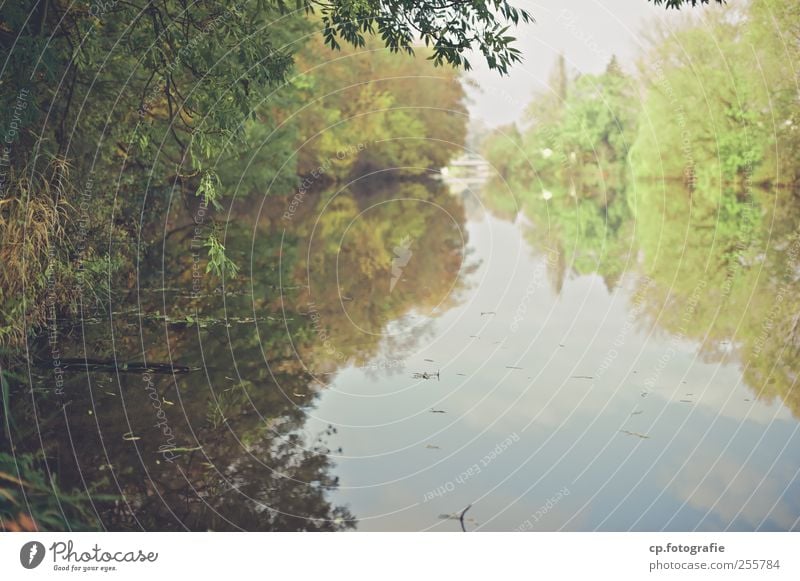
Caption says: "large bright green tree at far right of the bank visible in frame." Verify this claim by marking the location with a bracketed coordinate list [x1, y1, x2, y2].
[631, 0, 800, 185]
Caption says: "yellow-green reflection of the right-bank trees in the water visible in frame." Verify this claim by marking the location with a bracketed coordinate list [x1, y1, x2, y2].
[484, 177, 800, 418]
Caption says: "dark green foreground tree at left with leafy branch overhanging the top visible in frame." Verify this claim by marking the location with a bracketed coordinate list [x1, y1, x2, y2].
[0, 0, 516, 339]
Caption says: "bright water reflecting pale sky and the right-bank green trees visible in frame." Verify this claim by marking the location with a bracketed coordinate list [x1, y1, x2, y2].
[310, 177, 800, 530]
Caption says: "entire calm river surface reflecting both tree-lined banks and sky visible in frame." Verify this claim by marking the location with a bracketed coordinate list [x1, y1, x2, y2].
[7, 175, 800, 530]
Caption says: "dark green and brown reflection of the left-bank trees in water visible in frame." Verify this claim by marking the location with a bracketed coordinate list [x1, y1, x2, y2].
[9, 178, 466, 530]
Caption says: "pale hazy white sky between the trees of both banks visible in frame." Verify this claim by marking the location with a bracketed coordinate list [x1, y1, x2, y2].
[468, 0, 705, 127]
